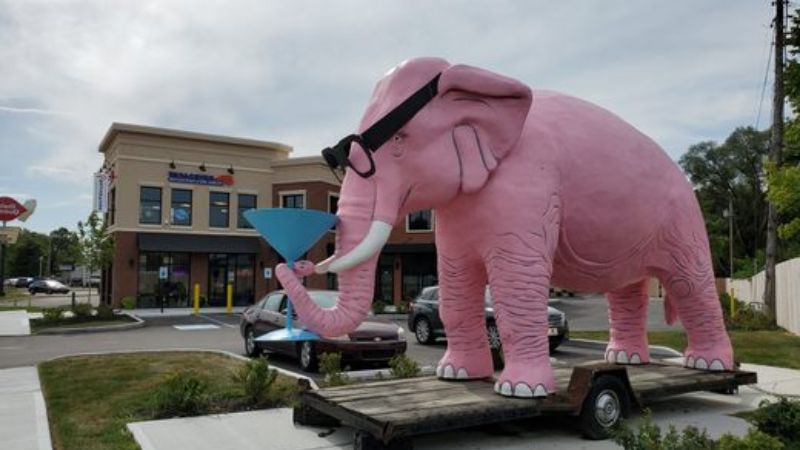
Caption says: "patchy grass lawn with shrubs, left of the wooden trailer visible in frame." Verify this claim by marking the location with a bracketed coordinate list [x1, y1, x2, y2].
[39, 352, 297, 450]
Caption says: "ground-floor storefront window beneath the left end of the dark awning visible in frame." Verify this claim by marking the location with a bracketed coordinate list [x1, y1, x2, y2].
[136, 252, 191, 308]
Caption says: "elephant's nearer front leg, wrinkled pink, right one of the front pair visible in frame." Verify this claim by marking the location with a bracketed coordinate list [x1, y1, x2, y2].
[487, 196, 559, 397]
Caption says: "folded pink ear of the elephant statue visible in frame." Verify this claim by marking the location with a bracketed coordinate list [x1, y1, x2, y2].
[439, 65, 533, 193]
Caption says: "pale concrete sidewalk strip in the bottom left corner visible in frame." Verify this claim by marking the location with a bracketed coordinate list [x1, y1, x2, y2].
[0, 367, 52, 450]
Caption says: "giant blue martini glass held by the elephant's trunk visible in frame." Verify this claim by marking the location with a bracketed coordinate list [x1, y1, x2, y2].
[244, 208, 337, 341]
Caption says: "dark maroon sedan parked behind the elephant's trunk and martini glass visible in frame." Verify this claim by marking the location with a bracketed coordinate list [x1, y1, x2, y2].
[239, 290, 406, 372]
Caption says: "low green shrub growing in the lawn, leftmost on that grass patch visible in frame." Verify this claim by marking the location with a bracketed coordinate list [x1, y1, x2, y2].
[152, 372, 209, 419]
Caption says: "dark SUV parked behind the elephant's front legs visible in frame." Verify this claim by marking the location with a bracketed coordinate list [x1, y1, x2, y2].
[408, 286, 569, 352]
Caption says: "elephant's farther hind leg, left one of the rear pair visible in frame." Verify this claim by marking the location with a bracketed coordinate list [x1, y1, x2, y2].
[606, 279, 650, 364]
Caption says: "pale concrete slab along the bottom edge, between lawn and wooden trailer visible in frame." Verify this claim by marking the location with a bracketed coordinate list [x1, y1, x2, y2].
[128, 408, 352, 450]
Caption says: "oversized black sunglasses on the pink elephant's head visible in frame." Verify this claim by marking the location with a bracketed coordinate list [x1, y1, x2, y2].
[322, 73, 442, 181]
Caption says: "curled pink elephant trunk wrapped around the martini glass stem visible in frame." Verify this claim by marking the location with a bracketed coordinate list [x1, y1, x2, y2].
[276, 177, 383, 337]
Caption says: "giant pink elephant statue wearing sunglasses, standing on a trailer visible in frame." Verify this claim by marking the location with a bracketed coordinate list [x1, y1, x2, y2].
[276, 58, 733, 397]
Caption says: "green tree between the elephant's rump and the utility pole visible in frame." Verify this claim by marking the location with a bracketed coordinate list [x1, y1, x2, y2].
[679, 127, 769, 276]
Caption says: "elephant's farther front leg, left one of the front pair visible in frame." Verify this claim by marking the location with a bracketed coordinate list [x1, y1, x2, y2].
[436, 251, 494, 379]
